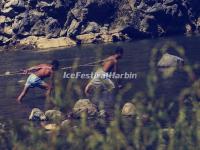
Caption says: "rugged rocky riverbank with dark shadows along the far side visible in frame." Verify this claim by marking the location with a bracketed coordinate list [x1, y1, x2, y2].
[0, 0, 200, 49]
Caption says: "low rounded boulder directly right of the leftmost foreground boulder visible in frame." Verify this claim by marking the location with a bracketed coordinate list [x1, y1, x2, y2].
[45, 110, 64, 121]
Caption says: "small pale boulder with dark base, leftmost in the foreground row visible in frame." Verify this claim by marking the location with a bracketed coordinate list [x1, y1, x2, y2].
[29, 108, 47, 121]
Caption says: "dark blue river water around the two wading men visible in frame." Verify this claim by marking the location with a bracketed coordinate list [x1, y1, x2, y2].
[0, 36, 200, 120]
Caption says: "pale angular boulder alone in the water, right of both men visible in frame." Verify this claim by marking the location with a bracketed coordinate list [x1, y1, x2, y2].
[158, 53, 184, 67]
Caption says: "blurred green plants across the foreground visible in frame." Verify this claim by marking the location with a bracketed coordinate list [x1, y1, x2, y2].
[0, 43, 200, 150]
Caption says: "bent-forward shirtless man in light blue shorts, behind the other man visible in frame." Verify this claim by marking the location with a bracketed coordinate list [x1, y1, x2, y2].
[17, 60, 59, 103]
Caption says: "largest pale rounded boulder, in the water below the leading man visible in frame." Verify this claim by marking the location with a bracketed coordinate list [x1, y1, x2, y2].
[73, 99, 98, 117]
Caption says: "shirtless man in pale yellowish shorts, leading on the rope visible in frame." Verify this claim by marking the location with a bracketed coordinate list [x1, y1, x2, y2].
[85, 47, 123, 95]
